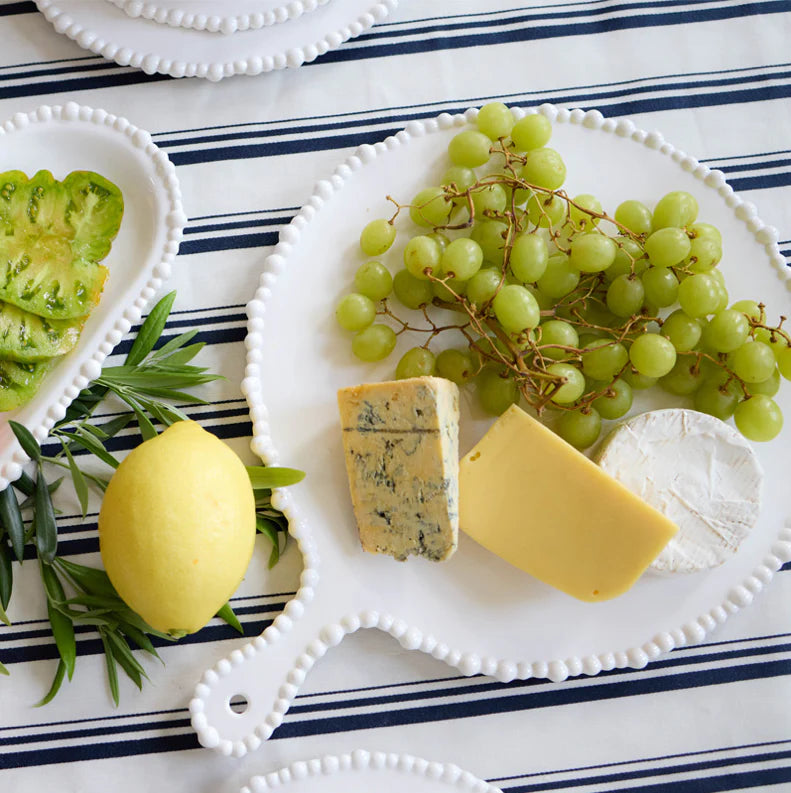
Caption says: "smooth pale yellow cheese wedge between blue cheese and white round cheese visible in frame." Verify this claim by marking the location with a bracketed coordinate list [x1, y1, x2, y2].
[459, 405, 678, 601]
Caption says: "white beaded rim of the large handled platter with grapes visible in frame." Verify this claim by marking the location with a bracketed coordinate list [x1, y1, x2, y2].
[190, 104, 791, 757]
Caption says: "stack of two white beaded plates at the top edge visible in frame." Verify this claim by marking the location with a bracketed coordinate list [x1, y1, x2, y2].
[35, 0, 398, 81]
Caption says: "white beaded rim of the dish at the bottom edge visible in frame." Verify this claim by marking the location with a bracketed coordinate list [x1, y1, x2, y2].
[239, 749, 502, 793]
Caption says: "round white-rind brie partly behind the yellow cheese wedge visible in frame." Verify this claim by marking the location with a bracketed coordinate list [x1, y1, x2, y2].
[598, 408, 763, 573]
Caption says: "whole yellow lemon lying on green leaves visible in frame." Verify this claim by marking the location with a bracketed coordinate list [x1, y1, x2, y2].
[99, 421, 256, 633]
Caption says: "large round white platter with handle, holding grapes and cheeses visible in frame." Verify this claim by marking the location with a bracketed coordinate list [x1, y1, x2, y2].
[192, 106, 791, 754]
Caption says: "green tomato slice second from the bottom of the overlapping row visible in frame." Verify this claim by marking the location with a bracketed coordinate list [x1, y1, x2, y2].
[0, 302, 87, 363]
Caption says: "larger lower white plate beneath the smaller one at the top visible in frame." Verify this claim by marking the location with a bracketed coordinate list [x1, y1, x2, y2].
[35, 0, 398, 81]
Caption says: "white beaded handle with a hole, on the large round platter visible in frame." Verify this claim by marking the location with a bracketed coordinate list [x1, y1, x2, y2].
[190, 593, 362, 757]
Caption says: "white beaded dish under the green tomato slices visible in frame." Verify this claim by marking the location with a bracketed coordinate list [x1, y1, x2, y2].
[0, 102, 186, 488]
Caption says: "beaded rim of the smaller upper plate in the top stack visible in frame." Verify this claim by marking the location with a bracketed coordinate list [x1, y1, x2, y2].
[103, 0, 330, 35]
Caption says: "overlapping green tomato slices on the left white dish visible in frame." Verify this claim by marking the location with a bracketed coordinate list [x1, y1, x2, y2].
[0, 171, 124, 411]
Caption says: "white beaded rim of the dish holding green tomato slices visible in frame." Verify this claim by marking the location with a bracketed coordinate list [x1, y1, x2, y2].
[0, 102, 186, 487]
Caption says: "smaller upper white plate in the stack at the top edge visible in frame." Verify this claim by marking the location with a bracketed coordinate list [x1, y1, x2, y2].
[107, 0, 329, 34]
